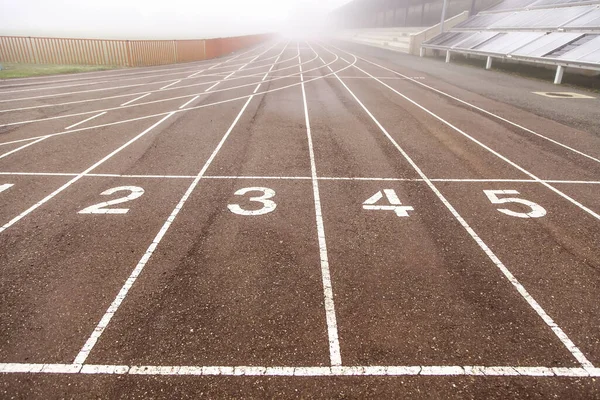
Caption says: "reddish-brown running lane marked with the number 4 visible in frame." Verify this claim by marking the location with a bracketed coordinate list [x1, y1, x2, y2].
[309, 43, 577, 366]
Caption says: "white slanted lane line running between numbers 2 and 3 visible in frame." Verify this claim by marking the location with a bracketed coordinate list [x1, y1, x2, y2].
[73, 56, 275, 365]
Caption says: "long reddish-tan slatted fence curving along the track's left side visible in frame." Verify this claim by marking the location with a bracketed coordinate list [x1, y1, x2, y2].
[0, 35, 269, 67]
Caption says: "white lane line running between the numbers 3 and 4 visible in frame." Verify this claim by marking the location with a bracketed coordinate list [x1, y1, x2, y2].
[299, 47, 342, 366]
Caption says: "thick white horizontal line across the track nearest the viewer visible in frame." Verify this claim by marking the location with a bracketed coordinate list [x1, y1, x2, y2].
[0, 363, 600, 378]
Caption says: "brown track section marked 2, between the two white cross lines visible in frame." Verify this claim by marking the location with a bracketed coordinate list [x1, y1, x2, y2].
[0, 177, 186, 363]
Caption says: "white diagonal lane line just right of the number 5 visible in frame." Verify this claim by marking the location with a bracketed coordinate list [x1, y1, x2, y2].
[328, 46, 600, 220]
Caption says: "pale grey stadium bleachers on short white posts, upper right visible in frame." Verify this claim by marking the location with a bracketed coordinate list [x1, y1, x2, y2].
[421, 0, 600, 84]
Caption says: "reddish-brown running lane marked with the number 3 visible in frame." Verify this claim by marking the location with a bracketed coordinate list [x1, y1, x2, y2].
[75, 46, 329, 365]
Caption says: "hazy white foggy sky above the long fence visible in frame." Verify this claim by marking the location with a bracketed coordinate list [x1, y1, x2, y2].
[0, 0, 349, 39]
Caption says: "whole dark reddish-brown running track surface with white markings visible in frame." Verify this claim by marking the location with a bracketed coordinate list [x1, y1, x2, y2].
[0, 39, 600, 399]
